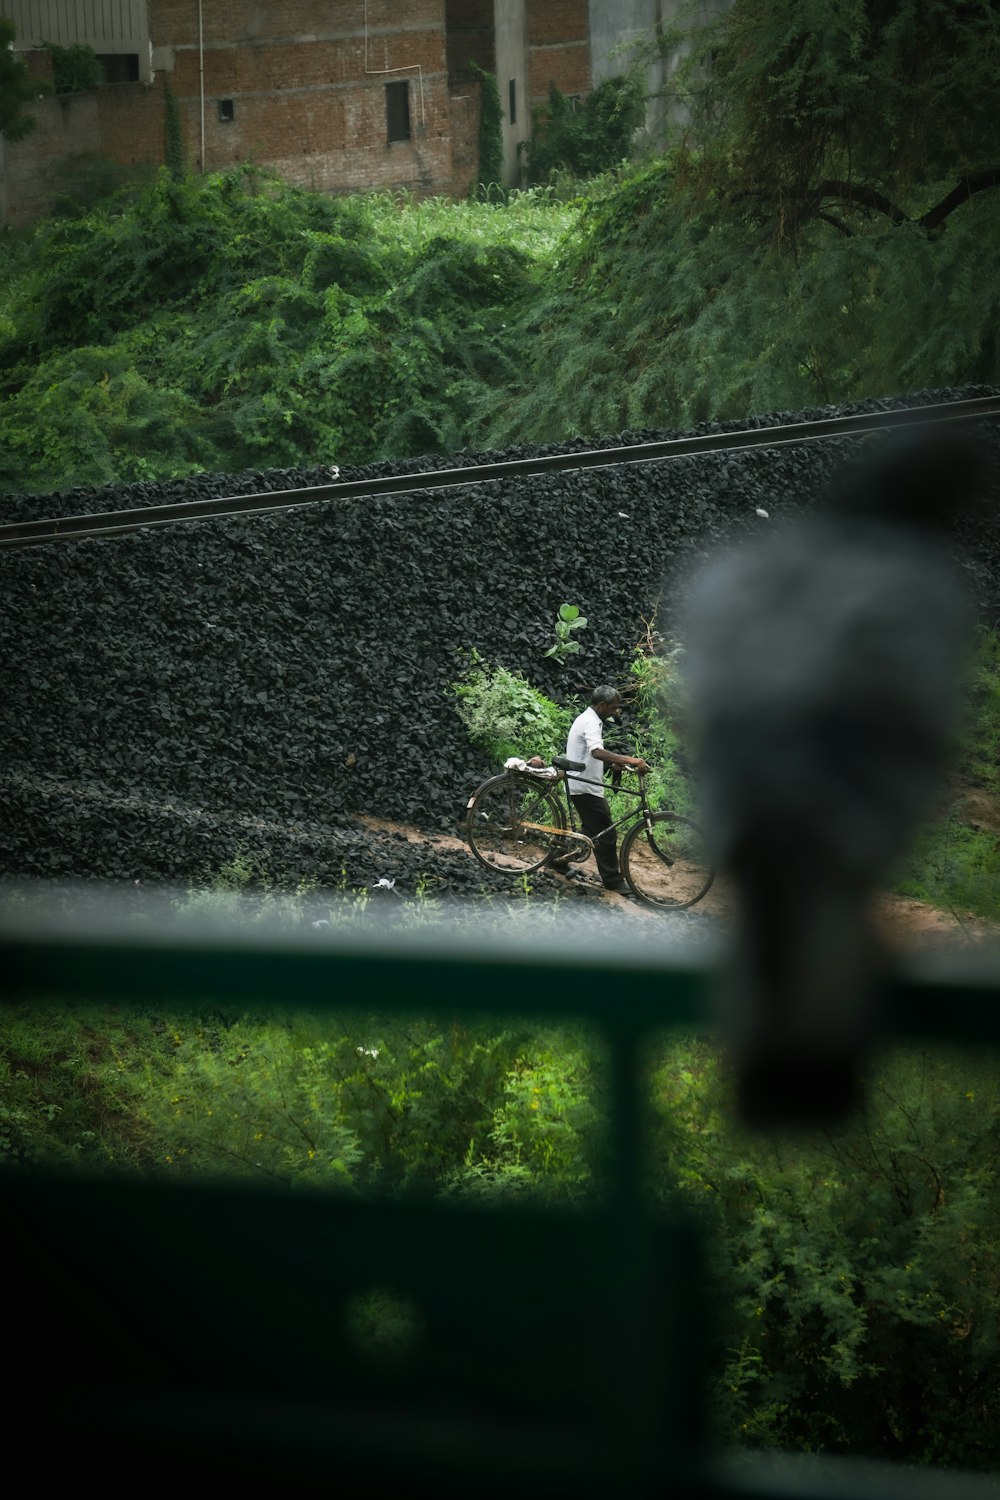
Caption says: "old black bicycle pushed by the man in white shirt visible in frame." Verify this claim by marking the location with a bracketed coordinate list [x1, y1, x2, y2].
[465, 755, 715, 911]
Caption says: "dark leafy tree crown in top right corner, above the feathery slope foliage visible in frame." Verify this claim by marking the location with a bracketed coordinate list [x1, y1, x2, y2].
[661, 0, 1000, 234]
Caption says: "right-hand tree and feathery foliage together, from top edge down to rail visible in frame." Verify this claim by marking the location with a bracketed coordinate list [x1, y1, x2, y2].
[483, 0, 1000, 441]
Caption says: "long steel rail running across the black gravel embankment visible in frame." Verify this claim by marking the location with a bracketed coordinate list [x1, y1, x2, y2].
[0, 396, 1000, 548]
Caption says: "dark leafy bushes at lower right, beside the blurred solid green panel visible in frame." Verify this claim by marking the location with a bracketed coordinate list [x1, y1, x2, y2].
[651, 1040, 1000, 1469]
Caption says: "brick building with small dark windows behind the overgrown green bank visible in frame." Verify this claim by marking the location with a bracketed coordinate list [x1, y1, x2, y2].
[0, 0, 591, 224]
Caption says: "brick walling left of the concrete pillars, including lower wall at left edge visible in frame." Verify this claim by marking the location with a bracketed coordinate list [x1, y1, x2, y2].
[0, 0, 480, 224]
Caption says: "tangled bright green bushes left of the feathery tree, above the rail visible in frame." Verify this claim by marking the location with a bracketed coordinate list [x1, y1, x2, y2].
[0, 168, 571, 492]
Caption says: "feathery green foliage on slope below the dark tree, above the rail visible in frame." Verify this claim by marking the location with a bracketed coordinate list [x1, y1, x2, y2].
[480, 152, 1000, 443]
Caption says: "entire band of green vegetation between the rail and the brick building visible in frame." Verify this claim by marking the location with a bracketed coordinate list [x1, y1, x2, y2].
[0, 0, 1000, 492]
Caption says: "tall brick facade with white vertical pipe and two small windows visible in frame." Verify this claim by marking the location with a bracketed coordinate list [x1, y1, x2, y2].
[151, 0, 453, 192]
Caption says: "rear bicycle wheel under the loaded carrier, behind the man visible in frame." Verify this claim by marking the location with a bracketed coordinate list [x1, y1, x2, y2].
[465, 776, 565, 875]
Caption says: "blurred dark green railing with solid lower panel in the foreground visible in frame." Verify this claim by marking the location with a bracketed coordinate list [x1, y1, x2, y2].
[0, 900, 1000, 1500]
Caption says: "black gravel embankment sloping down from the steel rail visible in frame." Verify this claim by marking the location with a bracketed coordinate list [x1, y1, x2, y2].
[0, 387, 1000, 900]
